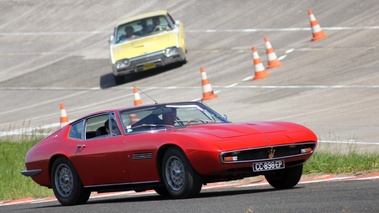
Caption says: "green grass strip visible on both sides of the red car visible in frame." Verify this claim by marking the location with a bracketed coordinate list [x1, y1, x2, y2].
[0, 136, 379, 201]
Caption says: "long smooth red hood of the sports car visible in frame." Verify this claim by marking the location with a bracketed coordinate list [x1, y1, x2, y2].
[175, 122, 317, 151]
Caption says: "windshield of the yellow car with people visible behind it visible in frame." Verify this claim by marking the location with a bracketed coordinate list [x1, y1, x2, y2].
[115, 15, 172, 43]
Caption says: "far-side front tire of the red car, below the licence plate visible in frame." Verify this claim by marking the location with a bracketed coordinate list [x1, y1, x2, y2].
[265, 165, 303, 189]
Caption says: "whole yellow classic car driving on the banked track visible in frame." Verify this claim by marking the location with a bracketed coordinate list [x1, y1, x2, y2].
[109, 10, 187, 84]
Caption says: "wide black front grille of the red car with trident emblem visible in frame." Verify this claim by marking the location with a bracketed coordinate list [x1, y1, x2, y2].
[220, 142, 316, 163]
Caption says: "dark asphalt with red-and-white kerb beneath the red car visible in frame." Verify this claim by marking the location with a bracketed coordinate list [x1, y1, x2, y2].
[0, 173, 379, 212]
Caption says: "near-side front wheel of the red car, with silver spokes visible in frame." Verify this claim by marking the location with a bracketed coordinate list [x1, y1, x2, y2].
[162, 147, 203, 199]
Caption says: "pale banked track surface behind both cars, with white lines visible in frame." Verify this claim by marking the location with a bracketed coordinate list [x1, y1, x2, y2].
[0, 0, 379, 151]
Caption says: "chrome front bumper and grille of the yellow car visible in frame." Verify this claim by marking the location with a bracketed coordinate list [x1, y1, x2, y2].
[112, 48, 186, 76]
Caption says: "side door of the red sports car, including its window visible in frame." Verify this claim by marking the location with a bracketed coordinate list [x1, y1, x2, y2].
[72, 113, 129, 186]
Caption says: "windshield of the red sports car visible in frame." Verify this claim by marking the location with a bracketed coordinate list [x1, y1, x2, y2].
[120, 103, 228, 133]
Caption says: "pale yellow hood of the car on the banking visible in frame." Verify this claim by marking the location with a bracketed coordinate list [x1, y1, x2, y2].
[111, 31, 178, 62]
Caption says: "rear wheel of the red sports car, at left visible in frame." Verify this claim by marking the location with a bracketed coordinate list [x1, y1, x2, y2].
[51, 157, 91, 206]
